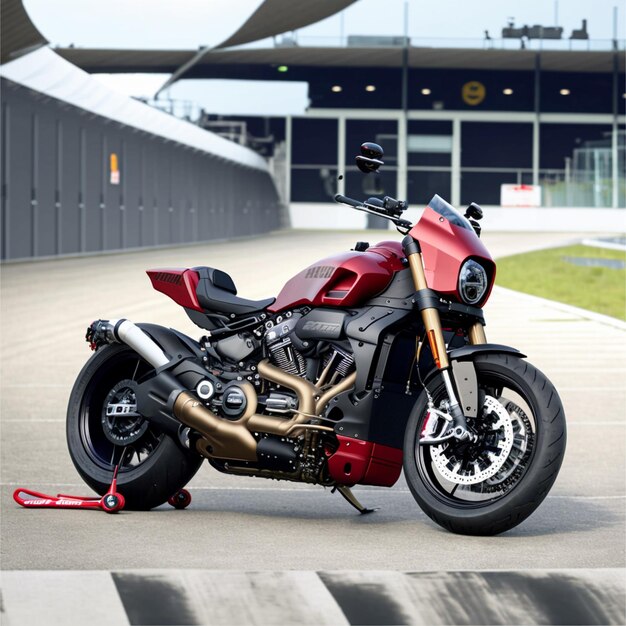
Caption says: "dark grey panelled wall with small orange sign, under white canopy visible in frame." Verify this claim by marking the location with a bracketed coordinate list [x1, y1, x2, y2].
[0, 79, 284, 260]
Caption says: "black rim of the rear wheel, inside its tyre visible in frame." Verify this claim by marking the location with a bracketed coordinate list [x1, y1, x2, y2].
[79, 350, 164, 472]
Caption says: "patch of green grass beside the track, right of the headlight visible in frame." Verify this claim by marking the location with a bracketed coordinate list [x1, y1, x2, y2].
[496, 245, 626, 320]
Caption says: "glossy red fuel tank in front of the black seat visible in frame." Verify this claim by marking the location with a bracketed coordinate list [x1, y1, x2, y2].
[269, 241, 406, 312]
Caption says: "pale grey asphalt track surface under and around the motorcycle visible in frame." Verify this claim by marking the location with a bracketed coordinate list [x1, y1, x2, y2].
[0, 231, 626, 626]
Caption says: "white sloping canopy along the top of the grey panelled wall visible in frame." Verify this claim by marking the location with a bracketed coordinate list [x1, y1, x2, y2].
[0, 48, 267, 171]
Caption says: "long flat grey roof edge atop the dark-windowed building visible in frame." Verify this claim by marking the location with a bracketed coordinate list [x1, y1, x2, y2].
[57, 46, 625, 78]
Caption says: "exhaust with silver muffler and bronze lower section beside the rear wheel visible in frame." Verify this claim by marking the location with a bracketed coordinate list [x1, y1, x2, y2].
[87, 319, 257, 461]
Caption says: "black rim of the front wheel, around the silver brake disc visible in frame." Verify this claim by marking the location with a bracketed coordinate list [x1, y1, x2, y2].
[414, 372, 538, 509]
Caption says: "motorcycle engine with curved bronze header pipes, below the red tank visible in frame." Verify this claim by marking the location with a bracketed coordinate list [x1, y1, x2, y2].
[173, 307, 355, 484]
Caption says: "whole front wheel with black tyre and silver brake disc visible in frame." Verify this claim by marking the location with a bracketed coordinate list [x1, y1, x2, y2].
[404, 354, 566, 535]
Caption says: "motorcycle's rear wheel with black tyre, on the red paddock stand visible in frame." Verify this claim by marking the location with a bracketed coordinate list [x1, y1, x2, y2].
[67, 345, 202, 510]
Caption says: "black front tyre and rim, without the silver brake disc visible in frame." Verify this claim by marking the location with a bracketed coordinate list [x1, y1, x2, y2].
[404, 354, 566, 535]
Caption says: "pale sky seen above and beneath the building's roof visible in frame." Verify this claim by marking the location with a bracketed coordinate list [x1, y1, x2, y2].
[23, 0, 626, 115]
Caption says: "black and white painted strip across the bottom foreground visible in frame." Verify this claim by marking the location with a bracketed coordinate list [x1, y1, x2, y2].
[0, 569, 626, 626]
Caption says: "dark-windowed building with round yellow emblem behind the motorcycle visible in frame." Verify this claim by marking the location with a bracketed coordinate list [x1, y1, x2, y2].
[59, 37, 626, 207]
